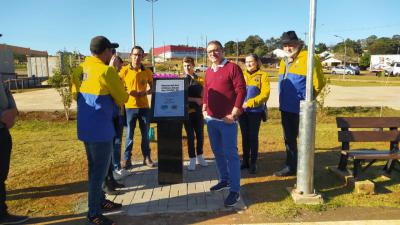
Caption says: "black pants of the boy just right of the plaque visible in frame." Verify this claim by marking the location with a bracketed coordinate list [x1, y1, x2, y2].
[184, 111, 204, 158]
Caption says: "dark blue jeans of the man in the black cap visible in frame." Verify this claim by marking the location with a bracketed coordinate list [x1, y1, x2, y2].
[84, 141, 113, 217]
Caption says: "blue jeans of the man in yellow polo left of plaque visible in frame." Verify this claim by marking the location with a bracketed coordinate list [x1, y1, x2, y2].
[124, 109, 150, 161]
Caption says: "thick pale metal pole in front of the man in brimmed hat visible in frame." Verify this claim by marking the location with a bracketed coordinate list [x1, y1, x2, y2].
[296, 0, 317, 196]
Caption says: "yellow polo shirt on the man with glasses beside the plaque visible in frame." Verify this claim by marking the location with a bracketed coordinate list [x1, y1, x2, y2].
[119, 64, 153, 109]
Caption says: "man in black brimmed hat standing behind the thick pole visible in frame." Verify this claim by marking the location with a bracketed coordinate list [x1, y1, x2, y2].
[274, 31, 325, 176]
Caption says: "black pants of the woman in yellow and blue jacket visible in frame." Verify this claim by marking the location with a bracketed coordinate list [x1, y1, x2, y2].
[239, 112, 261, 165]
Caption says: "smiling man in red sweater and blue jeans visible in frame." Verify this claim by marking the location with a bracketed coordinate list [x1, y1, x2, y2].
[203, 41, 246, 206]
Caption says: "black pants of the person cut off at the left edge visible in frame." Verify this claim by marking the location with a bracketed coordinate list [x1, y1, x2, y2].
[0, 128, 12, 217]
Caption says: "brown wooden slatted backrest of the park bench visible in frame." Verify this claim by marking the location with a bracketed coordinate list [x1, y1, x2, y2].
[336, 117, 400, 150]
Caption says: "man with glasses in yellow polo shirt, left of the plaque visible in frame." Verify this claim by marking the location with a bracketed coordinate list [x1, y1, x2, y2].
[119, 46, 154, 169]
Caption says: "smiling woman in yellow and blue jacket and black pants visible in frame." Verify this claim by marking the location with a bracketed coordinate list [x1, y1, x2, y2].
[239, 54, 270, 174]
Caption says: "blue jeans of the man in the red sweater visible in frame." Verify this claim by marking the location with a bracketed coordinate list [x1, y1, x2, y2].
[206, 119, 240, 192]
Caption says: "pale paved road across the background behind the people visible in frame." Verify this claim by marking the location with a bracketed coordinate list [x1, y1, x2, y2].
[14, 82, 400, 111]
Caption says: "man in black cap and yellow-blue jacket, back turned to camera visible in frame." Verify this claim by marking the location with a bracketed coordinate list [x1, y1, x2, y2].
[72, 36, 129, 225]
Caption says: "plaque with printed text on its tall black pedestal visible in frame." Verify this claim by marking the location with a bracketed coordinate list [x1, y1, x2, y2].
[151, 78, 188, 184]
